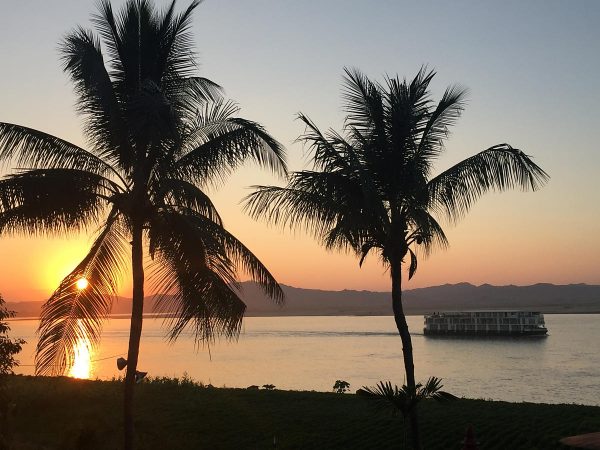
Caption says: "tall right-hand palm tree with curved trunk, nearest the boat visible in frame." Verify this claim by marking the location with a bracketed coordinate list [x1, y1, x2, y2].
[245, 67, 548, 448]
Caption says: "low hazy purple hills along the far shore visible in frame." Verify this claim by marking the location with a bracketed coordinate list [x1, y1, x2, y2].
[7, 282, 600, 317]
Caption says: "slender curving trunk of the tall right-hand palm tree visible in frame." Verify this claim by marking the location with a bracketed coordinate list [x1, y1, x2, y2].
[390, 261, 421, 450]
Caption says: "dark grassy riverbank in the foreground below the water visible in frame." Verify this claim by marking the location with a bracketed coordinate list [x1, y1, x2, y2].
[2, 376, 600, 450]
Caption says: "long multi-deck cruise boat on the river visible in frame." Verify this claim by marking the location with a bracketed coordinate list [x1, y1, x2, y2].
[423, 311, 548, 336]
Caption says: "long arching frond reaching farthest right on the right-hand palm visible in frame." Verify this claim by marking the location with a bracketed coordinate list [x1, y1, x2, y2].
[427, 144, 549, 221]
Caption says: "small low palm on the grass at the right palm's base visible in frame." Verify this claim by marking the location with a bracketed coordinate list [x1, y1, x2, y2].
[356, 377, 458, 446]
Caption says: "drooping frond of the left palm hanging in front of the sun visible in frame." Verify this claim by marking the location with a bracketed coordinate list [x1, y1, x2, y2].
[35, 212, 129, 375]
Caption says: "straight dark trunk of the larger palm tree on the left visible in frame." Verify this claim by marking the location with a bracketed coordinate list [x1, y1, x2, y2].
[123, 221, 144, 450]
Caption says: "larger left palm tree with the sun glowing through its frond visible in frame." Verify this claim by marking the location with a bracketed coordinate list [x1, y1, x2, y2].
[0, 0, 286, 449]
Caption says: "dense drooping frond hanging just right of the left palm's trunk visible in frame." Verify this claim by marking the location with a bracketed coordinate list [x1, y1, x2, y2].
[148, 212, 246, 342]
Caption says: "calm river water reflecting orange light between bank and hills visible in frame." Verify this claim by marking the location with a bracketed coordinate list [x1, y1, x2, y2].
[11, 314, 600, 405]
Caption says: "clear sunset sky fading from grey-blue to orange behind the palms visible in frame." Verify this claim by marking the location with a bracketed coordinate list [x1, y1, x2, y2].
[0, 0, 600, 301]
